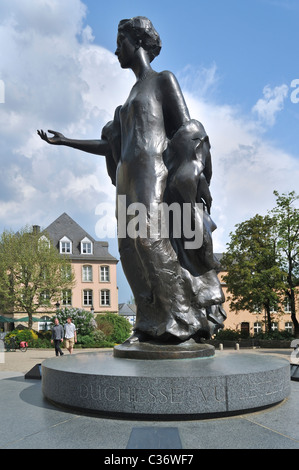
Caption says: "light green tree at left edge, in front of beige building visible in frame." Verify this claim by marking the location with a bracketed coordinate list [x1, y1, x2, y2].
[0, 227, 74, 328]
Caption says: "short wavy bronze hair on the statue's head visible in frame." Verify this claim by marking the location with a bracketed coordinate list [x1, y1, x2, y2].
[118, 16, 162, 62]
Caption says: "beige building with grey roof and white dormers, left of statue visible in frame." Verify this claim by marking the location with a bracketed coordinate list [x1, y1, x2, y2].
[9, 213, 118, 331]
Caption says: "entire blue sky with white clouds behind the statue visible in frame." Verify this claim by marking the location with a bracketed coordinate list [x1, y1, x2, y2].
[0, 0, 299, 302]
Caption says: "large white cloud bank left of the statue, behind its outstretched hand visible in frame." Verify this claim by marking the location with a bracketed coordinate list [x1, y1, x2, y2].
[0, 0, 133, 234]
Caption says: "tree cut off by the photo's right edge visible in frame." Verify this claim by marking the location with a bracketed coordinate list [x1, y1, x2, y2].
[271, 191, 299, 338]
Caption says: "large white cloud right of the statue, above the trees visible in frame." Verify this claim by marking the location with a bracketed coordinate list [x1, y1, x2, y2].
[185, 86, 299, 252]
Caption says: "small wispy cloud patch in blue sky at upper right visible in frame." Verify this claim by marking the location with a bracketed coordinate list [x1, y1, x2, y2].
[252, 84, 289, 126]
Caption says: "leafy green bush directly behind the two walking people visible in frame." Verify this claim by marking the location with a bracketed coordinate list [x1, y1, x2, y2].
[51, 307, 96, 336]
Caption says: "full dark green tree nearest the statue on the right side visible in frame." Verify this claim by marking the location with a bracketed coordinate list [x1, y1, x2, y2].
[221, 215, 284, 330]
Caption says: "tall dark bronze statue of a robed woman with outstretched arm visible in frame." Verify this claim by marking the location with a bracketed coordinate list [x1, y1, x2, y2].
[38, 17, 226, 343]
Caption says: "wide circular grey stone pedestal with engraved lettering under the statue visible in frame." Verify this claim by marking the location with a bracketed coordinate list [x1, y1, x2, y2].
[42, 351, 290, 419]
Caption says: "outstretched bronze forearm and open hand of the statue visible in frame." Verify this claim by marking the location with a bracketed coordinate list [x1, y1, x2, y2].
[37, 130, 109, 155]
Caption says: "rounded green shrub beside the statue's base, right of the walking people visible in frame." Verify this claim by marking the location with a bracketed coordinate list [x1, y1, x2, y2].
[95, 313, 131, 343]
